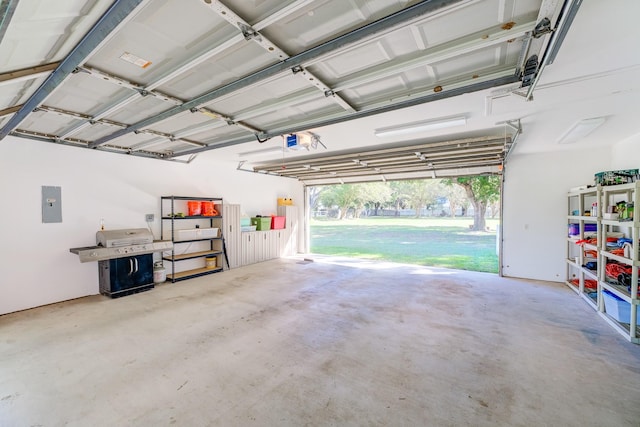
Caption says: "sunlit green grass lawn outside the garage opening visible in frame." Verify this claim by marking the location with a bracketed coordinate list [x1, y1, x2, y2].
[311, 217, 498, 273]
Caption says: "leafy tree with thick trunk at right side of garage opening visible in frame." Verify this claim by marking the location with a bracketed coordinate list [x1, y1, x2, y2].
[447, 175, 500, 231]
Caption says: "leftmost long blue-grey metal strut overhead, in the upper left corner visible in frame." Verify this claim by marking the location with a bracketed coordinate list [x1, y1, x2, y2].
[0, 0, 143, 140]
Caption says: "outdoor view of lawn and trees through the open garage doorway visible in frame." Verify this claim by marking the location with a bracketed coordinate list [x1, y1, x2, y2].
[308, 176, 500, 273]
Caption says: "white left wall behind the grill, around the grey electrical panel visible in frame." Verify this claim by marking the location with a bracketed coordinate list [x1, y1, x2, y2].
[0, 137, 303, 314]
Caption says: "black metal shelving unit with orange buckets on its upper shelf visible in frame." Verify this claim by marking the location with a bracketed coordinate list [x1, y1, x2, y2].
[160, 196, 226, 283]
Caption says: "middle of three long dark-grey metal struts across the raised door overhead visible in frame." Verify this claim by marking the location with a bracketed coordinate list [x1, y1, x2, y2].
[87, 0, 462, 148]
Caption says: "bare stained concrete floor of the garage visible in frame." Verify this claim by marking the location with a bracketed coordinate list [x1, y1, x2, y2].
[0, 257, 640, 426]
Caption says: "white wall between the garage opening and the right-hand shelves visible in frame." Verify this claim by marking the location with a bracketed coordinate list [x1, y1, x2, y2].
[503, 148, 612, 281]
